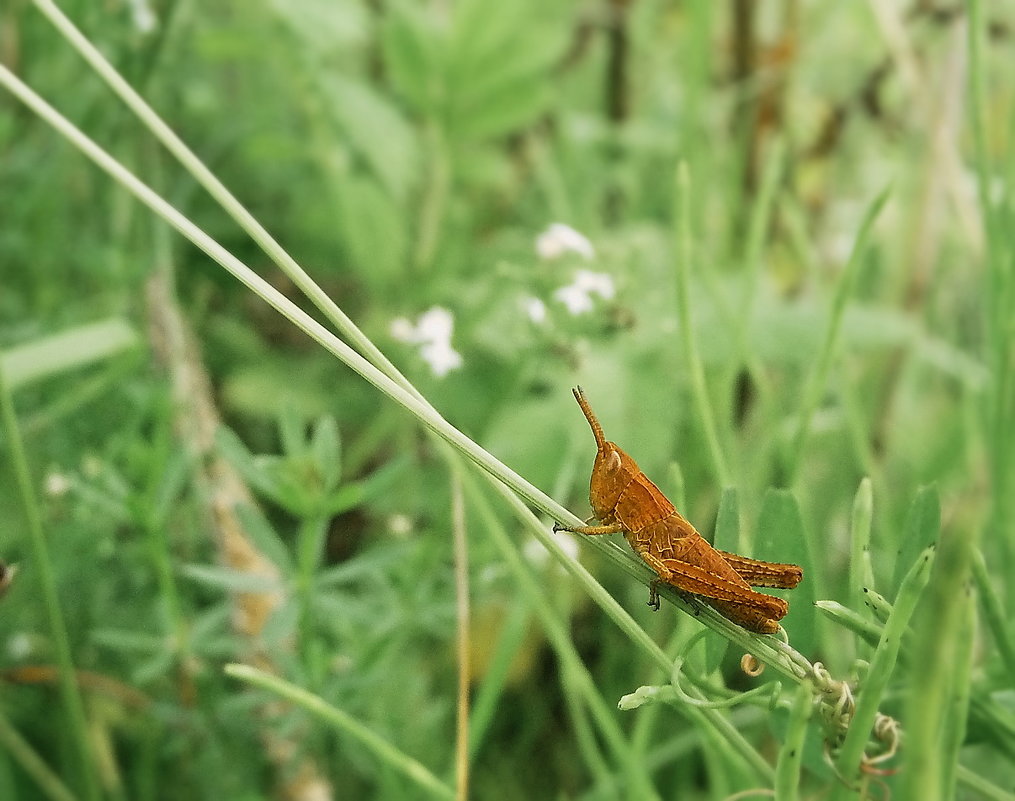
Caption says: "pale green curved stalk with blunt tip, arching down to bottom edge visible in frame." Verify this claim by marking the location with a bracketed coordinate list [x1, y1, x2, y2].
[225, 664, 455, 801]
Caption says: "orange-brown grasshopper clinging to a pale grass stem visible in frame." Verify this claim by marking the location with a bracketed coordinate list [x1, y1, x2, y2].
[553, 387, 803, 633]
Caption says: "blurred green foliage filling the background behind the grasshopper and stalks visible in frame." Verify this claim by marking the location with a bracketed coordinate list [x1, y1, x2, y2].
[0, 0, 1015, 799]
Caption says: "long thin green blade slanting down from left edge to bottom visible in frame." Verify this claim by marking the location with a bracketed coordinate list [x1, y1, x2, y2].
[0, 361, 99, 801]
